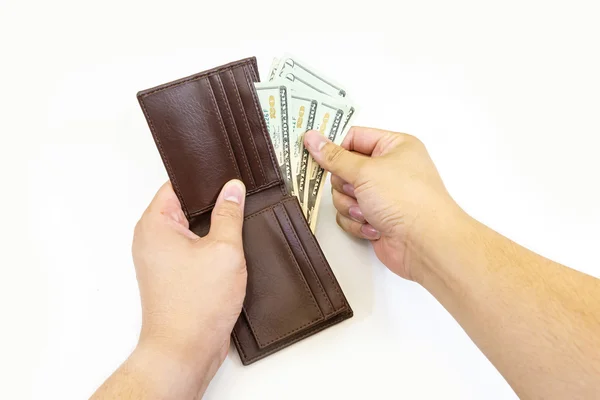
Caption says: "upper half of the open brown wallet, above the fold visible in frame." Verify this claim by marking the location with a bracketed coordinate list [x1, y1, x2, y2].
[138, 57, 283, 218]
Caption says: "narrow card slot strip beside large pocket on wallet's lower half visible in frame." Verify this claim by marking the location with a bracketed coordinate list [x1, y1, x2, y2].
[273, 202, 335, 317]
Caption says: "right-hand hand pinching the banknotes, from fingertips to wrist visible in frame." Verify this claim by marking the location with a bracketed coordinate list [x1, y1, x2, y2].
[304, 127, 452, 279]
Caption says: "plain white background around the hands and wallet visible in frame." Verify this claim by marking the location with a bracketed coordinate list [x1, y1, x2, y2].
[0, 0, 600, 399]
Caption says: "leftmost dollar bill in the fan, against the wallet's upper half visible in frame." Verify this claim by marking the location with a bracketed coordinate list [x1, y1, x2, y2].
[254, 82, 298, 196]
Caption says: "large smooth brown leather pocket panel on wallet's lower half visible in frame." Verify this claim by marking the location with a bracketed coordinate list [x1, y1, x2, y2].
[243, 204, 324, 348]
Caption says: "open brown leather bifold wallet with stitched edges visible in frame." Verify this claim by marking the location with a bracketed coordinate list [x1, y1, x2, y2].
[137, 57, 352, 365]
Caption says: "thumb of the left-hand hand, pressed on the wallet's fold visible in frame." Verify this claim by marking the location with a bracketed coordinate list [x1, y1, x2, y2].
[208, 179, 246, 246]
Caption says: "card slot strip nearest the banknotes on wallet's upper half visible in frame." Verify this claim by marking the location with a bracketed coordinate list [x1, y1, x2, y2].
[231, 66, 283, 190]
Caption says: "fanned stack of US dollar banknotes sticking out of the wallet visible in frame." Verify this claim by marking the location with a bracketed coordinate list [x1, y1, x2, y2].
[255, 55, 357, 232]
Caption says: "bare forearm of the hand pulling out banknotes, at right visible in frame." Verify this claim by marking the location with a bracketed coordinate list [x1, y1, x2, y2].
[422, 211, 600, 398]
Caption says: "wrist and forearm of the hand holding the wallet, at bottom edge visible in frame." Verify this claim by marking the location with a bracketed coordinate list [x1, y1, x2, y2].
[92, 343, 220, 400]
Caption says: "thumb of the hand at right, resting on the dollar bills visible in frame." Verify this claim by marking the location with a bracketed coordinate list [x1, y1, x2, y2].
[304, 131, 366, 185]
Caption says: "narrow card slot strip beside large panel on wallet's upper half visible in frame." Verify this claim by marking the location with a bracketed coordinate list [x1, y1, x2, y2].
[208, 75, 256, 190]
